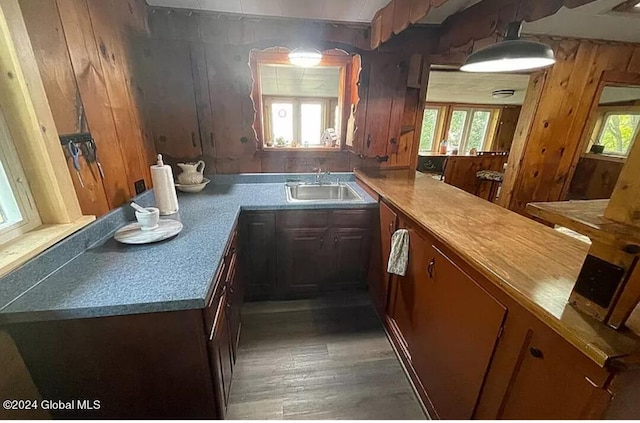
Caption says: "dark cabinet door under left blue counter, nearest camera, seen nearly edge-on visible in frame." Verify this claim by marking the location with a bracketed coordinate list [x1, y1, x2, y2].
[209, 292, 233, 418]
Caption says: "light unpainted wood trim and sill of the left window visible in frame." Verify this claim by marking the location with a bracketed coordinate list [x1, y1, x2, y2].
[0, 1, 95, 277]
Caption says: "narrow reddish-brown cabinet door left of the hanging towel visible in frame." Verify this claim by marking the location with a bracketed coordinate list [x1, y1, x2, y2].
[369, 202, 398, 316]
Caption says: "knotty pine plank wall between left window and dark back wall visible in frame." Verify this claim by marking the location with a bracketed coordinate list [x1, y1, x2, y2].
[20, 0, 155, 216]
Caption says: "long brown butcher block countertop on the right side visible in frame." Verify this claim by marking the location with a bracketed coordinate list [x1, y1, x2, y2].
[356, 170, 640, 367]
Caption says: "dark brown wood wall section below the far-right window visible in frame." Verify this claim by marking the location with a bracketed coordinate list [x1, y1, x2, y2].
[568, 154, 625, 200]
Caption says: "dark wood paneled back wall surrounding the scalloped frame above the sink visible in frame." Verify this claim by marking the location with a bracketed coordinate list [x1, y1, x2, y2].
[135, 9, 437, 173]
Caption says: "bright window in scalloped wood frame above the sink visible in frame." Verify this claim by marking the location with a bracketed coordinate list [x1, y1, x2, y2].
[250, 47, 360, 151]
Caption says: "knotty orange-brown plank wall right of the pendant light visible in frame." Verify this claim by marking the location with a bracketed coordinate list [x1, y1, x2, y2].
[500, 38, 640, 214]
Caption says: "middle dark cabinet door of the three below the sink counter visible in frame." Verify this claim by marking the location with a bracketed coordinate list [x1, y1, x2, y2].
[278, 228, 334, 298]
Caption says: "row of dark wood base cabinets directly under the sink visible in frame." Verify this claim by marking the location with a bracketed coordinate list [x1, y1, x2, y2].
[240, 209, 373, 300]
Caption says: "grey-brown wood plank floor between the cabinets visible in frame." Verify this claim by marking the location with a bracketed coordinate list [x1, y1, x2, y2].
[227, 294, 425, 420]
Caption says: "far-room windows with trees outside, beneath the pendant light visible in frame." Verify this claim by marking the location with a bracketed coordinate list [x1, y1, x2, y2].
[419, 105, 500, 154]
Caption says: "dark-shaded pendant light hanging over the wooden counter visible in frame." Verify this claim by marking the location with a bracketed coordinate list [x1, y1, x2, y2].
[460, 21, 556, 72]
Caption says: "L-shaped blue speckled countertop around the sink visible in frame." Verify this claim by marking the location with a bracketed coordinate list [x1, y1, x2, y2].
[0, 175, 377, 324]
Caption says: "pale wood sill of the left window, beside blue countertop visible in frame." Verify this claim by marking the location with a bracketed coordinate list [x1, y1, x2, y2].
[0, 216, 96, 277]
